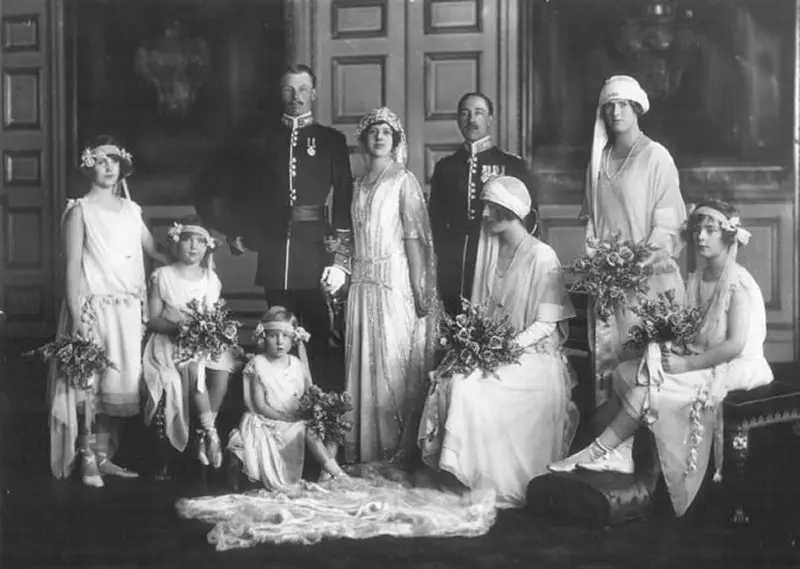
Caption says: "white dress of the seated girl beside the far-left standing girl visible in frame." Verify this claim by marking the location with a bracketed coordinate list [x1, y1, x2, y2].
[142, 266, 235, 451]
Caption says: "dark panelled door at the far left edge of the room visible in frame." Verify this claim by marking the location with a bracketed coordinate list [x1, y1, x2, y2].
[0, 0, 64, 339]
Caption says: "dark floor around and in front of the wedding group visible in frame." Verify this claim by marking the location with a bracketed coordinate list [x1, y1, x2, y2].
[0, 348, 800, 569]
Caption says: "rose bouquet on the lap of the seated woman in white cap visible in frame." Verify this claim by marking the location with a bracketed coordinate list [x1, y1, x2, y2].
[437, 298, 525, 377]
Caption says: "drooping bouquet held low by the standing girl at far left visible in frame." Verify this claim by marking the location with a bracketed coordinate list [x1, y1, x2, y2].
[23, 337, 117, 389]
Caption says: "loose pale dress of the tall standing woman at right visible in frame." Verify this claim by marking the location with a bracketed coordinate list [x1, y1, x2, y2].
[583, 139, 686, 405]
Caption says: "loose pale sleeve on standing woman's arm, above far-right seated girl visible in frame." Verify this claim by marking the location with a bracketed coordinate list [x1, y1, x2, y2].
[648, 145, 686, 258]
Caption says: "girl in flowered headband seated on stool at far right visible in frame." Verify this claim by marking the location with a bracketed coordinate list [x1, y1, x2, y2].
[550, 200, 773, 516]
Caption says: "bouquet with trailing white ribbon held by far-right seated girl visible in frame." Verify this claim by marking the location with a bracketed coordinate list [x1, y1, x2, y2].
[625, 290, 702, 424]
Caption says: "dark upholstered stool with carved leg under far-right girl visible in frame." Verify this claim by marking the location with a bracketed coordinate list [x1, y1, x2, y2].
[723, 381, 800, 524]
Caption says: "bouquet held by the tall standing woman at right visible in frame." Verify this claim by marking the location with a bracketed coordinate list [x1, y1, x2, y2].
[564, 232, 658, 320]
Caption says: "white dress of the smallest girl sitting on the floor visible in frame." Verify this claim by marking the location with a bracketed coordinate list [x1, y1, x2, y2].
[228, 355, 311, 490]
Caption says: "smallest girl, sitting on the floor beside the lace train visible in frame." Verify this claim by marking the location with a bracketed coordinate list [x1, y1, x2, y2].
[228, 306, 344, 490]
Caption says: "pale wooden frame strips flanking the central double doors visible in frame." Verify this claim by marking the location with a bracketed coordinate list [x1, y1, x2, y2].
[283, 0, 528, 155]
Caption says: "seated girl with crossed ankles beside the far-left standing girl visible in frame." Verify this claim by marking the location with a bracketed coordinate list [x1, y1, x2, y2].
[143, 216, 235, 479]
